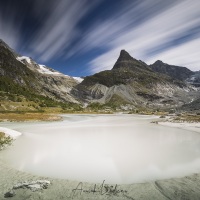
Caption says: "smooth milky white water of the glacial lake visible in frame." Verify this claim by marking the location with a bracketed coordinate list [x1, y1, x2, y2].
[0, 115, 200, 183]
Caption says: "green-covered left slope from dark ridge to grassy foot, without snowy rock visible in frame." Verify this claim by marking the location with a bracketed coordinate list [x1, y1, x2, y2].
[0, 44, 81, 112]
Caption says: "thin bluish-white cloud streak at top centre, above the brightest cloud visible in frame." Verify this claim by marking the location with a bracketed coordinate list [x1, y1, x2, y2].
[70, 0, 171, 56]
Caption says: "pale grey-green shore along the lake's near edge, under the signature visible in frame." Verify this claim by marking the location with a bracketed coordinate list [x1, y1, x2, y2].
[0, 117, 200, 200]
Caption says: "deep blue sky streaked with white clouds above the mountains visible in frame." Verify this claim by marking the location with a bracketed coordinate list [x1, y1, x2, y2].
[0, 0, 200, 76]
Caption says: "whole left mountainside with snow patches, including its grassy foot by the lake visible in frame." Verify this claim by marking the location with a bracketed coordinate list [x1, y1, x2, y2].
[0, 40, 85, 112]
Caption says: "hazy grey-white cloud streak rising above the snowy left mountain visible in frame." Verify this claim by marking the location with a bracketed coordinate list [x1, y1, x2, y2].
[32, 0, 99, 61]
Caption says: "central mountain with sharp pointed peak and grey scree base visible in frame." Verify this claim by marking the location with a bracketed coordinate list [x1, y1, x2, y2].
[71, 50, 195, 108]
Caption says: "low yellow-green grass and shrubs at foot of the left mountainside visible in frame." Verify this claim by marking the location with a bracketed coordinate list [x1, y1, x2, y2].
[0, 87, 82, 112]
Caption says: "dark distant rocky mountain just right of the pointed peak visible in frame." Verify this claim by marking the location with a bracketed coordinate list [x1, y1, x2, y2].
[149, 60, 194, 81]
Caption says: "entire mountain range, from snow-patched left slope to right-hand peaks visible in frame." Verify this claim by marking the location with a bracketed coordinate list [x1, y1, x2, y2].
[0, 38, 198, 109]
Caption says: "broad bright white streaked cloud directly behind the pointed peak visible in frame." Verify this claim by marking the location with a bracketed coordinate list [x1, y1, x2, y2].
[87, 0, 200, 73]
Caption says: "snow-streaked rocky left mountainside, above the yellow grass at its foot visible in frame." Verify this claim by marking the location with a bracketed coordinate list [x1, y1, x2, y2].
[0, 40, 80, 110]
